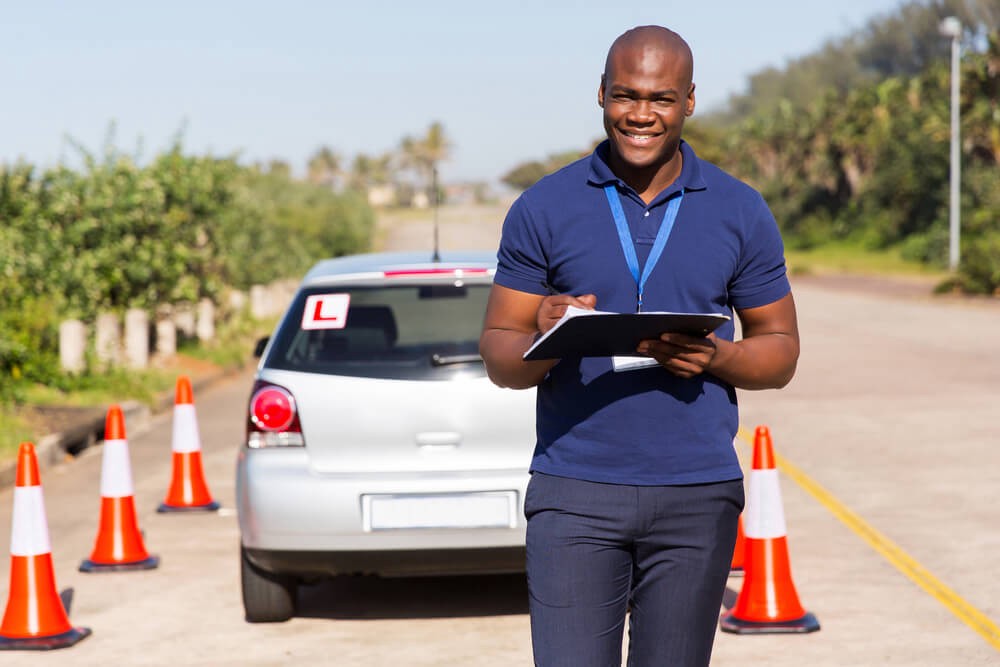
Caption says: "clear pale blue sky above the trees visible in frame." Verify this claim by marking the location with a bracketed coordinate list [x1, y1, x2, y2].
[0, 0, 916, 182]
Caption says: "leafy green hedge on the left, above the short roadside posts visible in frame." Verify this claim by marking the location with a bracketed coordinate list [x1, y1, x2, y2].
[0, 145, 374, 402]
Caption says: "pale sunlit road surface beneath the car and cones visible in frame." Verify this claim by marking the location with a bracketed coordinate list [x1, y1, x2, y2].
[0, 206, 1000, 667]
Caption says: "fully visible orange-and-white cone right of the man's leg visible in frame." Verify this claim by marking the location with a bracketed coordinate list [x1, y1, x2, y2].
[719, 426, 819, 634]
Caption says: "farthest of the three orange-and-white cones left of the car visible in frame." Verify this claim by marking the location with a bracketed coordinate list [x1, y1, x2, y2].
[156, 375, 219, 512]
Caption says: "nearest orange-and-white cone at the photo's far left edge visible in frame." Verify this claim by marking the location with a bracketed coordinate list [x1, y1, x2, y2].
[0, 442, 90, 651]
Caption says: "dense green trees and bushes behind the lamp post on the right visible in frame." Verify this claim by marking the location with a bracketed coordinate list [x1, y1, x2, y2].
[723, 35, 1000, 294]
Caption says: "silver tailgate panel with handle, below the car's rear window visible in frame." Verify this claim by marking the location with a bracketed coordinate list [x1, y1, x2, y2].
[264, 371, 535, 473]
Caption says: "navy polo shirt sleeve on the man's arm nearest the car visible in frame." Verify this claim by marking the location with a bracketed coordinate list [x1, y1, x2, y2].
[493, 194, 548, 295]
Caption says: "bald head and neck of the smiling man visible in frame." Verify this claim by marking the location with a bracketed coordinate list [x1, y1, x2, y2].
[597, 26, 694, 194]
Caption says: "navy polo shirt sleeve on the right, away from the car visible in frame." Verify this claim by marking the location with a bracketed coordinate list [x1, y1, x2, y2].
[729, 194, 792, 310]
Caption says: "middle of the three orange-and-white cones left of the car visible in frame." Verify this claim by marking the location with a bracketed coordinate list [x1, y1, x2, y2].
[80, 405, 160, 572]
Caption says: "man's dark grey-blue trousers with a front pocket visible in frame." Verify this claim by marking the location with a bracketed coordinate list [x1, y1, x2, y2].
[524, 473, 744, 667]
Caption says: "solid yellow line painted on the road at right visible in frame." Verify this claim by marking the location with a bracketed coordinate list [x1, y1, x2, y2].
[737, 427, 1000, 650]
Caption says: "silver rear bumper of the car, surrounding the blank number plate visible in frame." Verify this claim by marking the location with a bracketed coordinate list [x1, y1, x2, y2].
[236, 448, 528, 574]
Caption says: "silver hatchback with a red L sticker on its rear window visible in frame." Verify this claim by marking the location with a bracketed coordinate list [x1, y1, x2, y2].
[236, 253, 535, 622]
